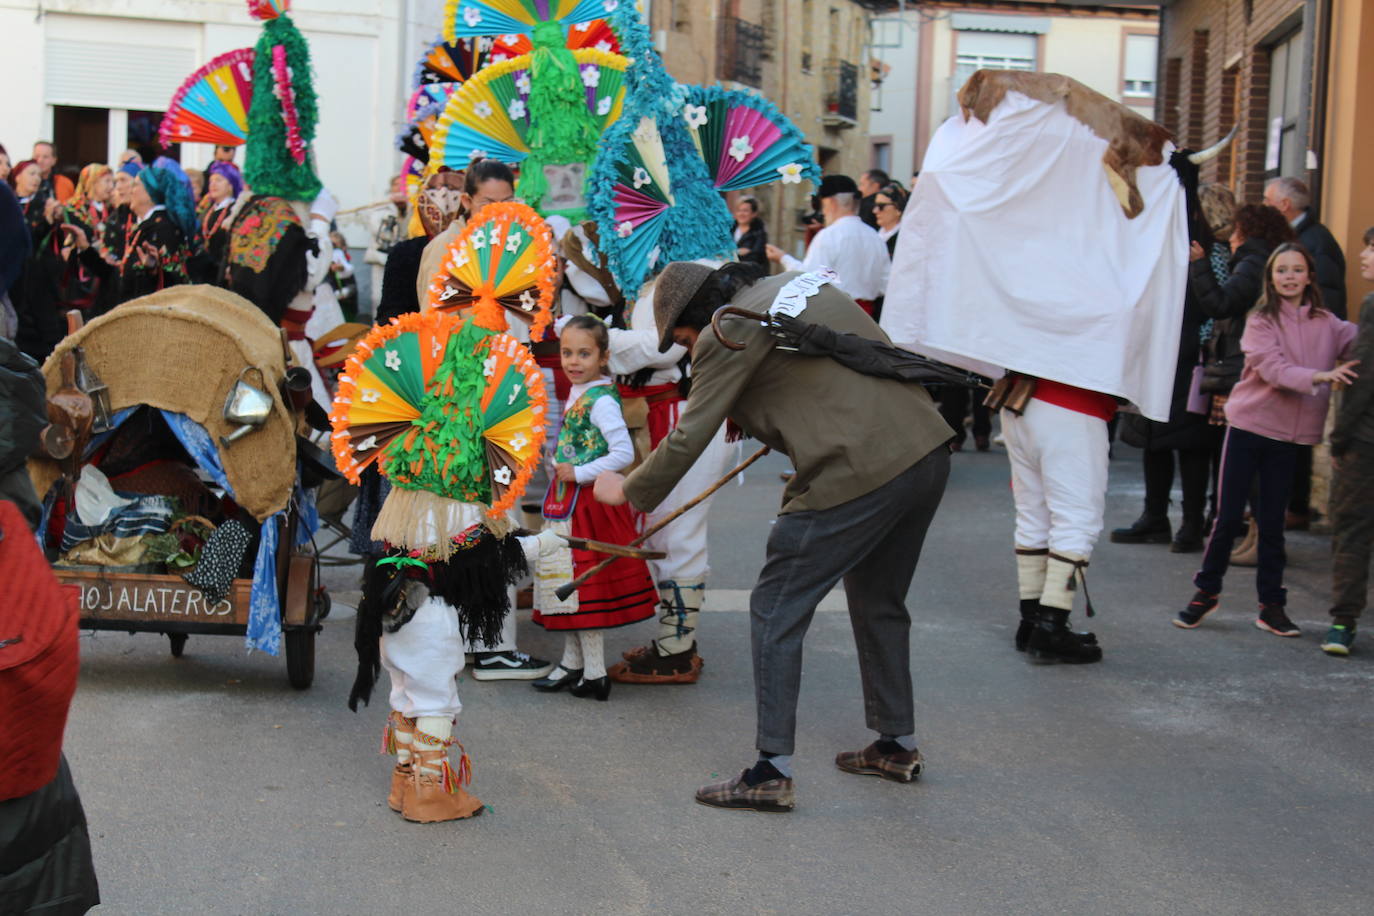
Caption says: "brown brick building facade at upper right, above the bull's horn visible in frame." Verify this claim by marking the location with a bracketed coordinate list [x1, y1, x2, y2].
[1158, 0, 1304, 202]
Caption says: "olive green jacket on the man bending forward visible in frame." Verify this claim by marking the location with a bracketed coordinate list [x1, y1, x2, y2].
[625, 272, 954, 514]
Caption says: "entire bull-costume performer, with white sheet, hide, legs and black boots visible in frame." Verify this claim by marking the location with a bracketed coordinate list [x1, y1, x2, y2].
[882, 70, 1189, 663]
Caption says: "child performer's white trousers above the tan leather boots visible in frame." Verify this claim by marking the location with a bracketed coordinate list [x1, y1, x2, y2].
[382, 597, 467, 718]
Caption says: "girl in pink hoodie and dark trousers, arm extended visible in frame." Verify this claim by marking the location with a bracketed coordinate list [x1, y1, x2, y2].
[1173, 242, 1358, 636]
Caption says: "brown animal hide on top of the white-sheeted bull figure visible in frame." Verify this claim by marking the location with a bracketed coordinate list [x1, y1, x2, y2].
[959, 70, 1173, 218]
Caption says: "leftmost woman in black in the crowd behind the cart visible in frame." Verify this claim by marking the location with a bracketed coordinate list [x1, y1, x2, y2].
[10, 159, 65, 363]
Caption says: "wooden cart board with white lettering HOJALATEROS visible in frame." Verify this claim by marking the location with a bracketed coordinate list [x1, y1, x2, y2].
[54, 569, 250, 623]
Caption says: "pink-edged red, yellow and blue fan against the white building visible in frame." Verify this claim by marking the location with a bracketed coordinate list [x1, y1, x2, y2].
[158, 48, 253, 147]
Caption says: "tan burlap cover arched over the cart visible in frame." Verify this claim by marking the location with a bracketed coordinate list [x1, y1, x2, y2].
[29, 286, 295, 522]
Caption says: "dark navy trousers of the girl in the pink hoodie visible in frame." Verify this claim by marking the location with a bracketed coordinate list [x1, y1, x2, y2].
[1193, 427, 1305, 606]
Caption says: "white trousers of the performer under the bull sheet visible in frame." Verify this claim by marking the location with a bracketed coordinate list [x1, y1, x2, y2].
[1002, 398, 1107, 558]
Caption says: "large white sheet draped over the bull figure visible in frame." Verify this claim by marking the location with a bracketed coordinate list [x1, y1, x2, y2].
[881, 71, 1189, 420]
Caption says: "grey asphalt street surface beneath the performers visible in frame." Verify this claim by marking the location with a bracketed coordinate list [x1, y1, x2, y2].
[66, 449, 1374, 916]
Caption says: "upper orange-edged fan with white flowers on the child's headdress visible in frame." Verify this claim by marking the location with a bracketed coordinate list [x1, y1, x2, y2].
[425, 203, 558, 341]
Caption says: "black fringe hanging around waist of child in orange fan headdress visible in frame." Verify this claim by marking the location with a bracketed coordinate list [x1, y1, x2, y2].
[348, 530, 529, 713]
